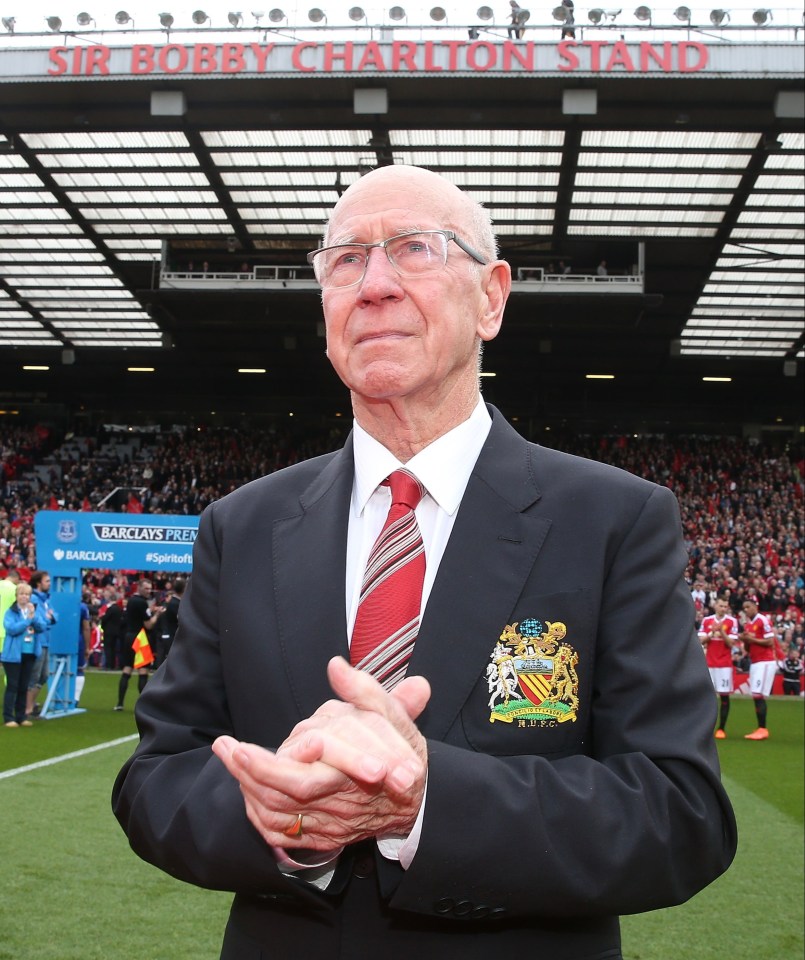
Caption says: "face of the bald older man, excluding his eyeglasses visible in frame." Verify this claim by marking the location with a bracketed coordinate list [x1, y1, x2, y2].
[323, 171, 508, 405]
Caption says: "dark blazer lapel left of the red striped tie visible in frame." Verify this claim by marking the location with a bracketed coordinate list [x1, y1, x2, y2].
[272, 436, 354, 717]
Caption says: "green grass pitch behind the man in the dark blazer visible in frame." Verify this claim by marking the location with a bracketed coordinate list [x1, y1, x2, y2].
[0, 673, 805, 960]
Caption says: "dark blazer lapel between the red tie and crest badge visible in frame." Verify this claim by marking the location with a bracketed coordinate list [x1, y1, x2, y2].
[408, 411, 550, 738]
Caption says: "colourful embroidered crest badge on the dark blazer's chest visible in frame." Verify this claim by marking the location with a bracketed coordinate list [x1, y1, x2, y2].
[486, 617, 579, 727]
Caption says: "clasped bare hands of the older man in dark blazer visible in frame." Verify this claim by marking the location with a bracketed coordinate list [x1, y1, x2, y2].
[212, 657, 430, 851]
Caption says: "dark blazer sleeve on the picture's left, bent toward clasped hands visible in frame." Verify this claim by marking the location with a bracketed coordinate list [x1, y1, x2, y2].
[112, 509, 318, 898]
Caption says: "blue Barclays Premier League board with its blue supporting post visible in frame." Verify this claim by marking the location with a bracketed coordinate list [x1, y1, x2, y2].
[34, 510, 199, 719]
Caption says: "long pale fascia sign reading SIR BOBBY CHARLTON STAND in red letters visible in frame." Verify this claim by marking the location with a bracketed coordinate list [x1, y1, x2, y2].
[0, 40, 802, 82]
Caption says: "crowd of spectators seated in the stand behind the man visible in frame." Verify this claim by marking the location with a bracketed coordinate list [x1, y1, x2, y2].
[0, 424, 805, 668]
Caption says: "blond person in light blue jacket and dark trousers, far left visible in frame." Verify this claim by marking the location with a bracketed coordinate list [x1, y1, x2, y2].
[0, 583, 47, 727]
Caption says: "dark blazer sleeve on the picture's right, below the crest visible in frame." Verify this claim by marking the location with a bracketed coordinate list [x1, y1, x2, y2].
[391, 487, 736, 919]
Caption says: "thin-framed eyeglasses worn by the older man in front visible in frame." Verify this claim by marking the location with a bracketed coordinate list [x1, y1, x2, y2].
[307, 230, 489, 287]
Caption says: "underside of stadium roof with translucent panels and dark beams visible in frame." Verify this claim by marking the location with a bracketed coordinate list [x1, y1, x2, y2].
[0, 31, 805, 424]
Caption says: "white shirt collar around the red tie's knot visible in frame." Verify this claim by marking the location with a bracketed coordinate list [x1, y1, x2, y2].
[352, 398, 492, 516]
